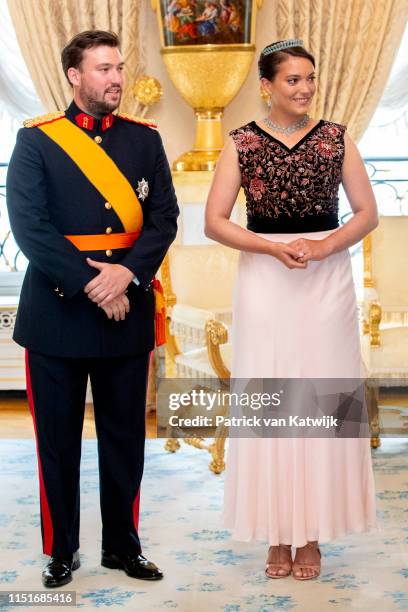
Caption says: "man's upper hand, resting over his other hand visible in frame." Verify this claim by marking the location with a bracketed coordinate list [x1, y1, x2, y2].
[84, 257, 134, 307]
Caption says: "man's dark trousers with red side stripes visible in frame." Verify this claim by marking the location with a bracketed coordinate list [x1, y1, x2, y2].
[26, 351, 149, 556]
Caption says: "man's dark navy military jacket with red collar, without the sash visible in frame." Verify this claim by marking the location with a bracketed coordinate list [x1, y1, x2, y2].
[7, 102, 178, 357]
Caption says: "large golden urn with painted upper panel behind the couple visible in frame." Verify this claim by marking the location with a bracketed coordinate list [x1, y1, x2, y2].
[152, 0, 262, 171]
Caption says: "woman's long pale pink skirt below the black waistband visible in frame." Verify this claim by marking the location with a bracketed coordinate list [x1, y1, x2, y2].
[224, 230, 376, 547]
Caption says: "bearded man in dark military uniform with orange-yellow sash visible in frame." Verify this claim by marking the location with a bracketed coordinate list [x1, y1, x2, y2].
[7, 31, 178, 587]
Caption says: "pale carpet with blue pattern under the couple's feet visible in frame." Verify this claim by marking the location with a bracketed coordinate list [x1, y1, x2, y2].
[0, 439, 408, 612]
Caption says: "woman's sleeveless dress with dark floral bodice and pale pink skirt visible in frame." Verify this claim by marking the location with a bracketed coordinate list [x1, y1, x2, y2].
[224, 120, 376, 547]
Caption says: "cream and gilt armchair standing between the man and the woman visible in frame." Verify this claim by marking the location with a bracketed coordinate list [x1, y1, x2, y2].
[161, 244, 238, 474]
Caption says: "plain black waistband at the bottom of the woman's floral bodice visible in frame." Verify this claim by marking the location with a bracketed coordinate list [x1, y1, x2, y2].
[247, 213, 339, 234]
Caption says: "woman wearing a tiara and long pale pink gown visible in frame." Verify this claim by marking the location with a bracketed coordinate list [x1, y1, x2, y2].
[206, 40, 378, 580]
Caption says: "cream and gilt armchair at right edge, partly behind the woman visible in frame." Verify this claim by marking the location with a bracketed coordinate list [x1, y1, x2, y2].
[362, 216, 408, 448]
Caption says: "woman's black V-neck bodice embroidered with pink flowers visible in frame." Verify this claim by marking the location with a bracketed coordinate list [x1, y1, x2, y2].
[230, 119, 346, 233]
